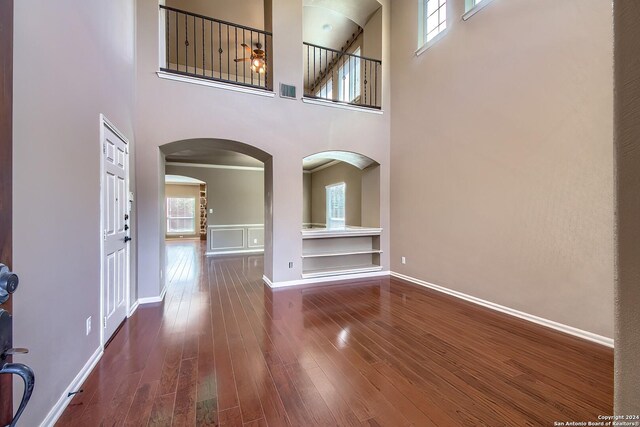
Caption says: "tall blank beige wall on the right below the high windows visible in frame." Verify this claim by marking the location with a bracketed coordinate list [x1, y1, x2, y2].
[391, 0, 614, 337]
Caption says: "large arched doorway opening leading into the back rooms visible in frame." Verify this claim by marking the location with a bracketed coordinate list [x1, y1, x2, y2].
[161, 139, 272, 294]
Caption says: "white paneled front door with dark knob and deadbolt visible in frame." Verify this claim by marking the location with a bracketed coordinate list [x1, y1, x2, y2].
[102, 119, 129, 344]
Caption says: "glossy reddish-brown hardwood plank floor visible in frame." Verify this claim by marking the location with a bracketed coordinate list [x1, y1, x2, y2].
[57, 242, 613, 426]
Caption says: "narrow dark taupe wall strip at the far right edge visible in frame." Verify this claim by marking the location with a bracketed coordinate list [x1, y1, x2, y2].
[614, 0, 640, 415]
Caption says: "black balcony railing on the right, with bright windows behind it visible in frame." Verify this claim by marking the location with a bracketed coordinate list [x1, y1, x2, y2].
[304, 43, 382, 109]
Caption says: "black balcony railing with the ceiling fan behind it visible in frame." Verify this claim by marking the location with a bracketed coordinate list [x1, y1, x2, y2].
[160, 6, 273, 90]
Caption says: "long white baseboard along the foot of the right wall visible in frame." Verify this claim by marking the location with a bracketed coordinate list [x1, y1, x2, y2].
[391, 271, 613, 348]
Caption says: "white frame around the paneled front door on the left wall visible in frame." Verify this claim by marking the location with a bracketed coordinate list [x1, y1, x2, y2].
[97, 113, 131, 350]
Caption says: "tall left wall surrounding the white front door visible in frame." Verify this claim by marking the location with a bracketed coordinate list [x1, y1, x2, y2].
[12, 0, 136, 426]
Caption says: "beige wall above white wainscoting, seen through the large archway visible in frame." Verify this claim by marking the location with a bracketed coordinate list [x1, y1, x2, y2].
[165, 165, 264, 225]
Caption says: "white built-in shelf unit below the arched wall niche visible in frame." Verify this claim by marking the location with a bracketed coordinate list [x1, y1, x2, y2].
[302, 227, 382, 279]
